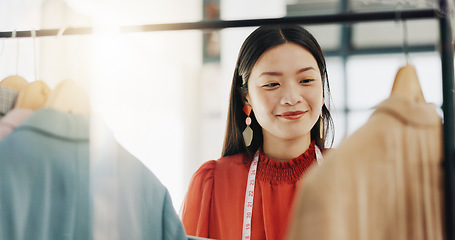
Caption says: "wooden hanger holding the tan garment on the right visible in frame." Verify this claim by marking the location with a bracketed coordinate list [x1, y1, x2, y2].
[391, 64, 425, 102]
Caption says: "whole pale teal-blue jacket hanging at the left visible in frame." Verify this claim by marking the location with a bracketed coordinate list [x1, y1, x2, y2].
[0, 109, 187, 240]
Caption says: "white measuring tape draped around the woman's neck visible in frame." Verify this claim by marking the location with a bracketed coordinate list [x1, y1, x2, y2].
[242, 145, 323, 240]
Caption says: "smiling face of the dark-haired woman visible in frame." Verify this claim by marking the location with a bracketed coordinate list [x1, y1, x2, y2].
[246, 43, 324, 144]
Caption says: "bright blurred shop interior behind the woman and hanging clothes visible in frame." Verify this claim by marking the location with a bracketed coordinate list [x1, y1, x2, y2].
[0, 0, 448, 212]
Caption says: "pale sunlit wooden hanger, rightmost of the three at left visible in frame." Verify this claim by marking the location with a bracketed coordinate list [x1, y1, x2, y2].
[44, 80, 90, 116]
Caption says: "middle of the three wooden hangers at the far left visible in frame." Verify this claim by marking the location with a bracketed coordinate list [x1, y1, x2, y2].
[14, 81, 51, 110]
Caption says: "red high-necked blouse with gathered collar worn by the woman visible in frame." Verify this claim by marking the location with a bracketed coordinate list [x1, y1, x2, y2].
[182, 142, 316, 240]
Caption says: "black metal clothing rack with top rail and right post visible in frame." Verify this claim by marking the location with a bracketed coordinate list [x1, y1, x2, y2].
[0, 0, 455, 240]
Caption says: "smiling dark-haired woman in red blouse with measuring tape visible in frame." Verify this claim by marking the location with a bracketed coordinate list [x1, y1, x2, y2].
[182, 25, 333, 240]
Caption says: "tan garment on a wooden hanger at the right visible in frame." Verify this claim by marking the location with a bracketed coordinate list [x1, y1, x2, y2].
[288, 97, 444, 240]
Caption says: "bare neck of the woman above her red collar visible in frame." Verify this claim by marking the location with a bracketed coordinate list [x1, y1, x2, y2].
[262, 132, 311, 162]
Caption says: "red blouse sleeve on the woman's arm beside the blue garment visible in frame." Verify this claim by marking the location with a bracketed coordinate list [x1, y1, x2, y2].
[182, 160, 216, 237]
